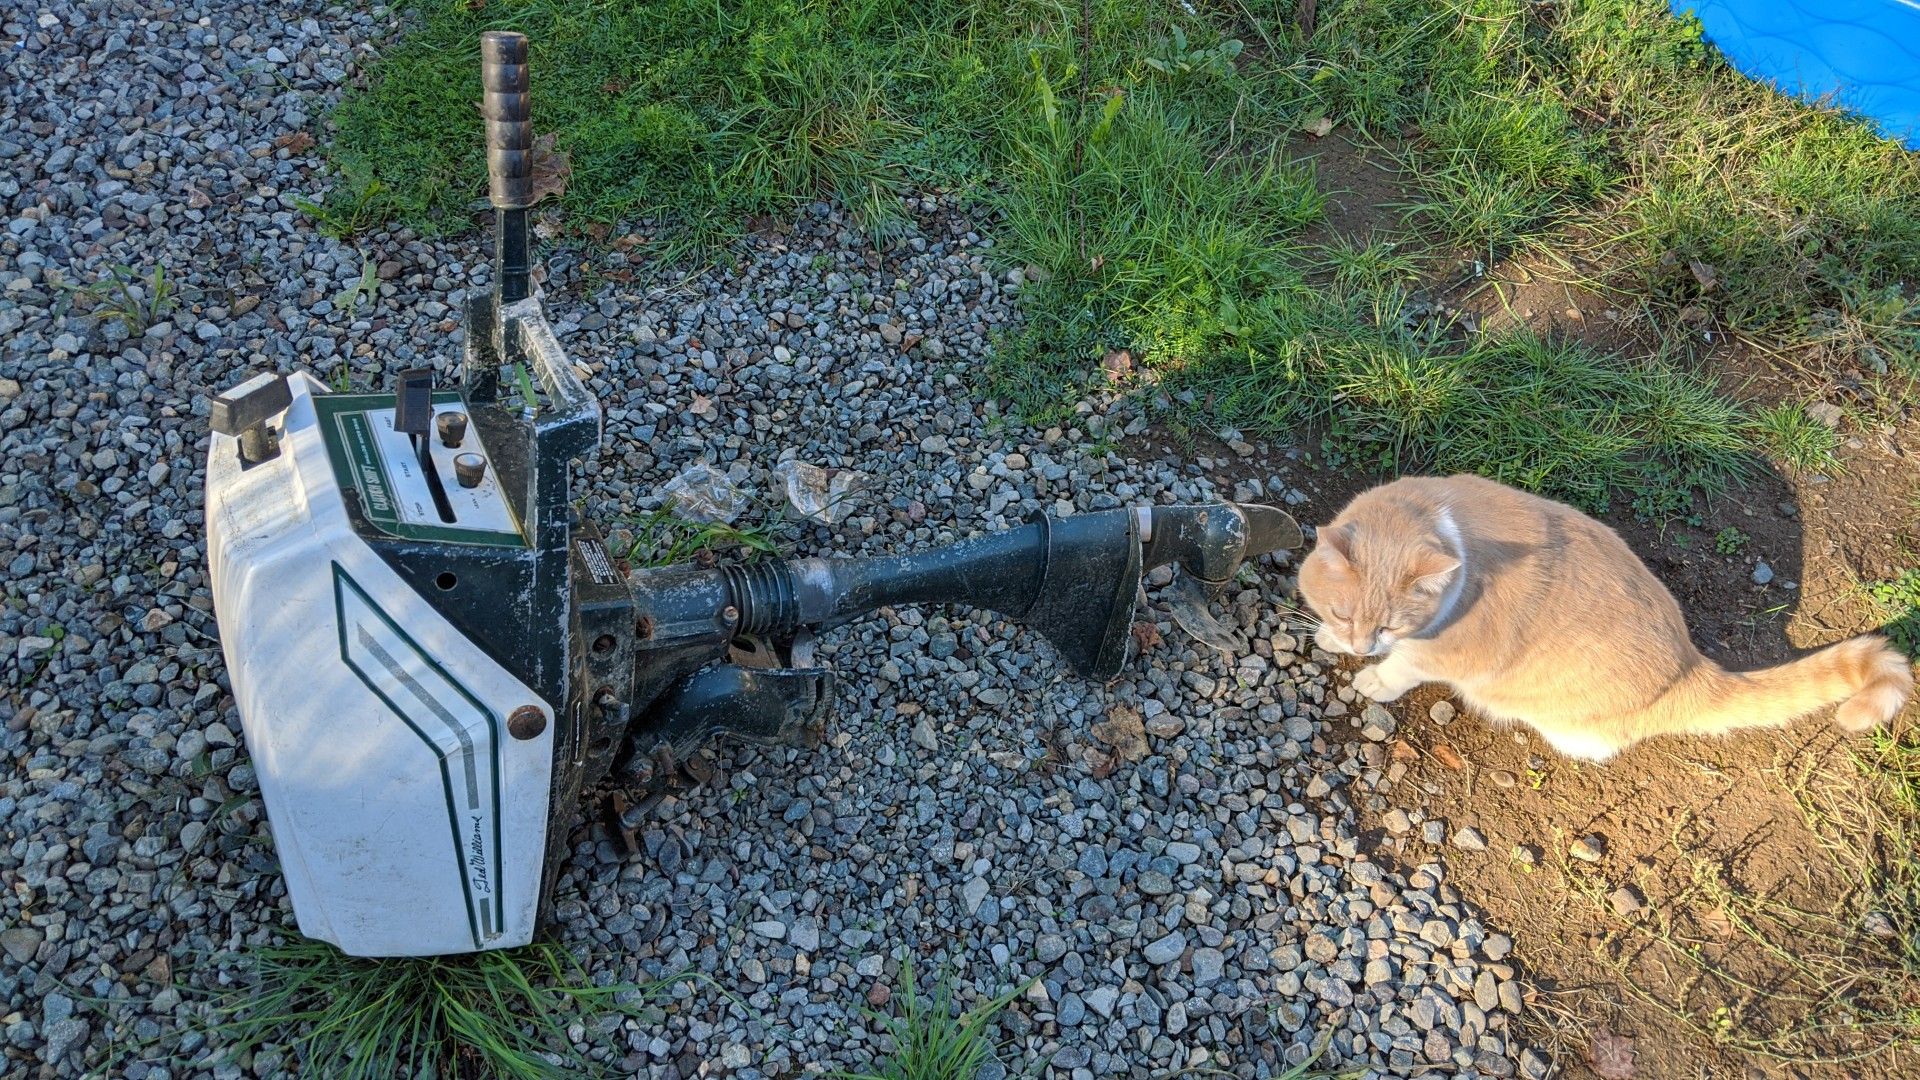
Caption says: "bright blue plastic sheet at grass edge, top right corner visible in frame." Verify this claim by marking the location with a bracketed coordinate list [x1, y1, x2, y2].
[1672, 0, 1920, 150]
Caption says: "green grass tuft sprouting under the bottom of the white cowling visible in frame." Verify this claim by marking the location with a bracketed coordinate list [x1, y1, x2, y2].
[213, 938, 659, 1080]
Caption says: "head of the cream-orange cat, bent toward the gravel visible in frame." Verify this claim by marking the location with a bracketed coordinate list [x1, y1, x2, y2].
[1300, 521, 1459, 655]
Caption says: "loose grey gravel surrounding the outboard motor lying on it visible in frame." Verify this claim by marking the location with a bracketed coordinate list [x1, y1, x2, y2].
[0, 0, 1544, 1080]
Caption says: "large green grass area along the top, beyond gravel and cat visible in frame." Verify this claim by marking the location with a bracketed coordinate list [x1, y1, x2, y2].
[334, 0, 1920, 513]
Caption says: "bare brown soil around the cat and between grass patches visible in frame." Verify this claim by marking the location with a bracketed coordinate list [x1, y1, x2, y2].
[1125, 136, 1920, 1080]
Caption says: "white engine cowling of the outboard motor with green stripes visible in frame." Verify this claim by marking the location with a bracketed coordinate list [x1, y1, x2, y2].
[207, 375, 559, 955]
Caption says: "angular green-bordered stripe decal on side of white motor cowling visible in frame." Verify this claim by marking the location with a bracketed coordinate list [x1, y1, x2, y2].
[332, 563, 507, 949]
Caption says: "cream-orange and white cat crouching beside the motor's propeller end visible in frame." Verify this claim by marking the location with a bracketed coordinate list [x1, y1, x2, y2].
[1300, 477, 1914, 761]
